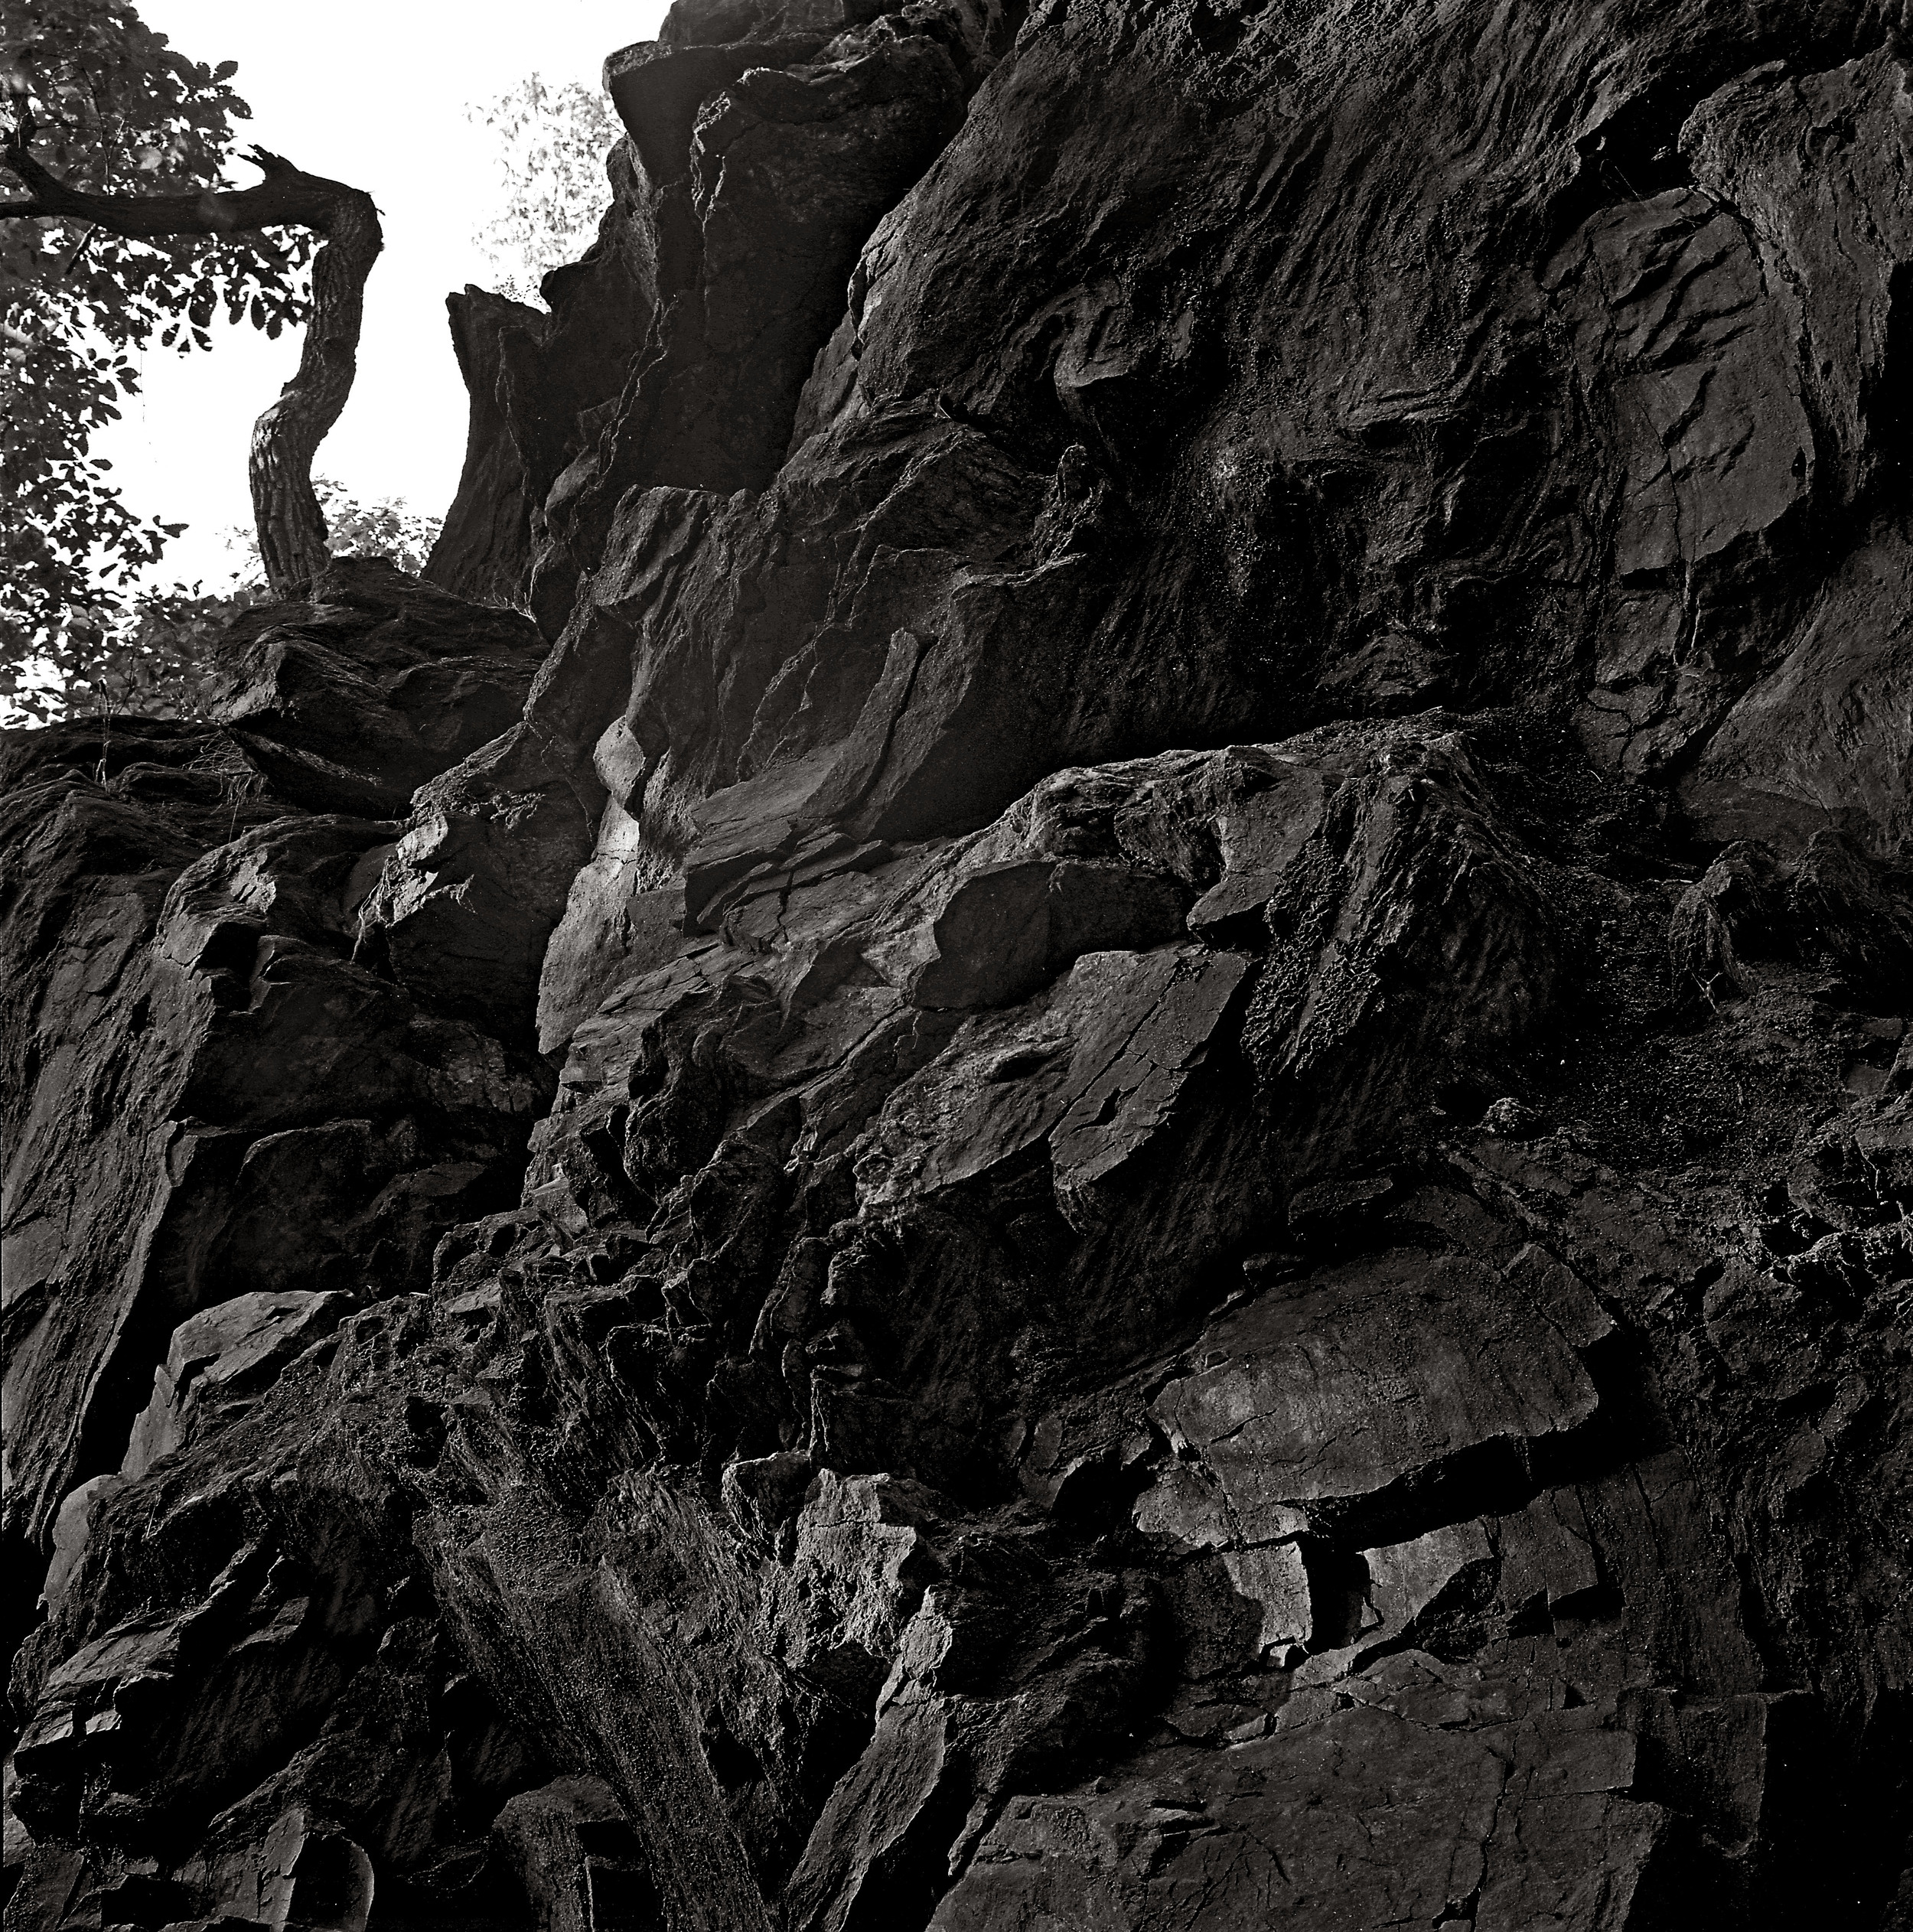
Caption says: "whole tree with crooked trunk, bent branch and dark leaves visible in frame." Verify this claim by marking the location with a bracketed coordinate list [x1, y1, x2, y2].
[0, 0, 383, 718]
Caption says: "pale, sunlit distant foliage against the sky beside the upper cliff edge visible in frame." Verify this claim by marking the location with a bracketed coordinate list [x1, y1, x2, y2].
[468, 73, 624, 303]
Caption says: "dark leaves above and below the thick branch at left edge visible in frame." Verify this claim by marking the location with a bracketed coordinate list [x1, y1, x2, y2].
[0, 0, 311, 709]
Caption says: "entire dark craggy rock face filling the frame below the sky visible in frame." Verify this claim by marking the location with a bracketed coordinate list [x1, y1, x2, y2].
[0, 0, 1913, 1932]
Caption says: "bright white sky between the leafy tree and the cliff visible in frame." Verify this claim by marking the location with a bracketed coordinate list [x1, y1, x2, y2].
[106, 0, 666, 589]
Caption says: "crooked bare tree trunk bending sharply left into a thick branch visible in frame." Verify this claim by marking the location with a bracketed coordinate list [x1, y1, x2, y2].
[0, 133, 385, 597]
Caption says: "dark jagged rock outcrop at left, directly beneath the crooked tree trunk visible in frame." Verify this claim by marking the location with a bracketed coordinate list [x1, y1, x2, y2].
[4, 560, 549, 1631]
